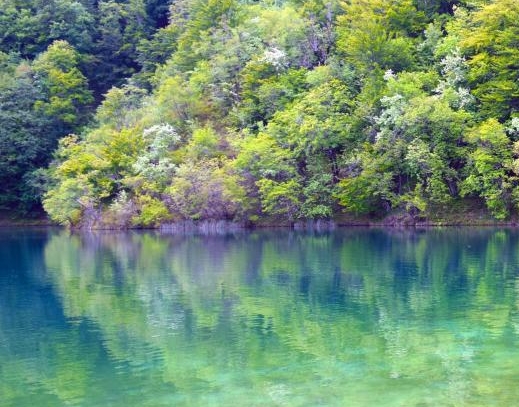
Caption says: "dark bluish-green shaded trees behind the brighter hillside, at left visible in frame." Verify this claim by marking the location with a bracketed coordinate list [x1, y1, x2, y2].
[0, 0, 169, 213]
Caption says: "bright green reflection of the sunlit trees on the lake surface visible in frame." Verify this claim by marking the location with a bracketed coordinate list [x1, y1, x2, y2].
[4, 229, 519, 403]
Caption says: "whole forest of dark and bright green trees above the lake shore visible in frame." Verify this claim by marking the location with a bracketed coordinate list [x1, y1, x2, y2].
[0, 0, 519, 228]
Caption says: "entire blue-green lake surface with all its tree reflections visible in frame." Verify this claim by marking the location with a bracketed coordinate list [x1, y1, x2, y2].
[0, 229, 519, 407]
